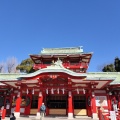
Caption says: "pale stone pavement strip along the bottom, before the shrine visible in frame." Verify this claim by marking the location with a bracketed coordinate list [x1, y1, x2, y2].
[4, 116, 98, 120]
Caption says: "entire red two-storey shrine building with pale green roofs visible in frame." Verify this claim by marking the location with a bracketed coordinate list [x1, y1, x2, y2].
[0, 47, 120, 119]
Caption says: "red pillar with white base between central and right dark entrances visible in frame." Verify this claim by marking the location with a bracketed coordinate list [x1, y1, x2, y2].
[68, 91, 73, 119]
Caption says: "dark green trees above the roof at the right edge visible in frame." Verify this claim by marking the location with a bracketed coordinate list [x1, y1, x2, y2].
[102, 57, 120, 72]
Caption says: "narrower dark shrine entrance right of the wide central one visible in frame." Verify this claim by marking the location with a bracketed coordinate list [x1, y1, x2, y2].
[73, 95, 87, 115]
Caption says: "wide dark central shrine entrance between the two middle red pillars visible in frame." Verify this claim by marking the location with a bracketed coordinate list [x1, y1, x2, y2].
[46, 95, 68, 115]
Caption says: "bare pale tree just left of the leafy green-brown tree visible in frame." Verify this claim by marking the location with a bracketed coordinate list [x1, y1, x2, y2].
[6, 57, 18, 73]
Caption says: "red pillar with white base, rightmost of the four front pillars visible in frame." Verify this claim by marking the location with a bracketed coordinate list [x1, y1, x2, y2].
[91, 91, 98, 119]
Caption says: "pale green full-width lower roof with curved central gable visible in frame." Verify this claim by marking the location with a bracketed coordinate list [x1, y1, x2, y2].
[0, 71, 120, 89]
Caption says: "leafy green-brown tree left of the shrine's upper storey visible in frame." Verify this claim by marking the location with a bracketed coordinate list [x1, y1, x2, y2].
[16, 58, 35, 73]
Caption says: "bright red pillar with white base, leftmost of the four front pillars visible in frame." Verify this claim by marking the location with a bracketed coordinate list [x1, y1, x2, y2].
[14, 92, 22, 118]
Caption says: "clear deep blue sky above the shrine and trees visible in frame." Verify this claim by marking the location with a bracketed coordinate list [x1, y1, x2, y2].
[0, 0, 120, 72]
